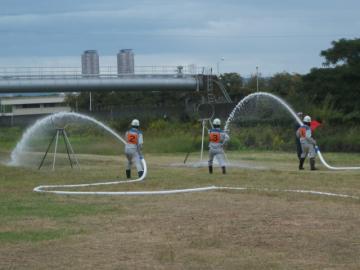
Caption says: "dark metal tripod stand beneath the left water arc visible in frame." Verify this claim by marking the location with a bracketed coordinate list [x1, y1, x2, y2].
[38, 128, 80, 170]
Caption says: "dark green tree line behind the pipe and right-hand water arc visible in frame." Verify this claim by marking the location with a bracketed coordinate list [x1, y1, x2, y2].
[67, 38, 360, 124]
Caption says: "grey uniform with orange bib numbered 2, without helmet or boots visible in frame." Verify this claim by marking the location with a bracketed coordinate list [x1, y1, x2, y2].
[125, 128, 144, 172]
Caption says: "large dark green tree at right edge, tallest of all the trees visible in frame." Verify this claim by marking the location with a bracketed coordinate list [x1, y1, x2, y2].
[302, 39, 360, 116]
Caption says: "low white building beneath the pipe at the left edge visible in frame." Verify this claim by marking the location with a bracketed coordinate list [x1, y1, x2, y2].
[0, 95, 71, 125]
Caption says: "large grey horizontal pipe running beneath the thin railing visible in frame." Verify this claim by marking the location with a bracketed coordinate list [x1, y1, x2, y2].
[0, 75, 202, 93]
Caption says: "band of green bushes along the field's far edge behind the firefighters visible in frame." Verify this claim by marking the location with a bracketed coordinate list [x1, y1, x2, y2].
[0, 118, 360, 153]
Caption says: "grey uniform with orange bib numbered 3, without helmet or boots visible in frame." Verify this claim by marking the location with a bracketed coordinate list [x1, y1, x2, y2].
[209, 128, 230, 167]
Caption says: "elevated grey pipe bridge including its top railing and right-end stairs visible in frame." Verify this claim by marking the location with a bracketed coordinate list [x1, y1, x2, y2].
[0, 66, 231, 103]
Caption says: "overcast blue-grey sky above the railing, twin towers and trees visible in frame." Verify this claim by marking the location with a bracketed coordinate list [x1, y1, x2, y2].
[0, 0, 360, 76]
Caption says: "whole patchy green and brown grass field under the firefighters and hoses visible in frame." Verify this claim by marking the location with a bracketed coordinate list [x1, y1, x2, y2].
[0, 151, 360, 270]
